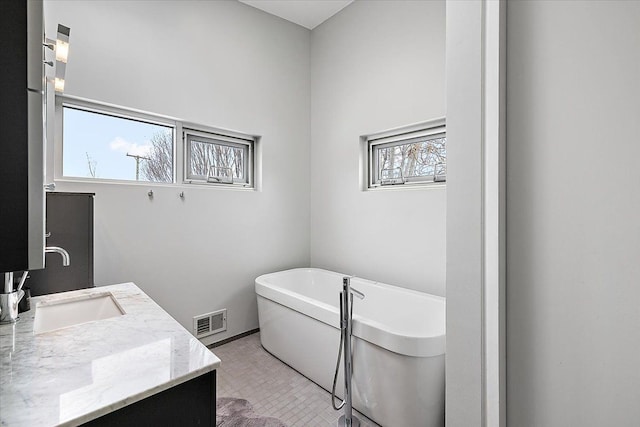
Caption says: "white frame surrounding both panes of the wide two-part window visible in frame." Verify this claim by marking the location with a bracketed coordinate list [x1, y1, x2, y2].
[49, 95, 260, 190]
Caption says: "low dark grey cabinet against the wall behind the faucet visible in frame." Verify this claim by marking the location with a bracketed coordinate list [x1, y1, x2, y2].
[27, 192, 94, 296]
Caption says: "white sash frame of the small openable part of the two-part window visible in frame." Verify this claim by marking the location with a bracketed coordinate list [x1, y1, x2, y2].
[182, 125, 256, 188]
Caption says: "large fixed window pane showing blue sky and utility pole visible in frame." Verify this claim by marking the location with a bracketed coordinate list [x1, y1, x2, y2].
[62, 105, 175, 182]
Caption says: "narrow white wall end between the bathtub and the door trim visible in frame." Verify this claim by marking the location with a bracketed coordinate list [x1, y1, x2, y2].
[445, 0, 484, 427]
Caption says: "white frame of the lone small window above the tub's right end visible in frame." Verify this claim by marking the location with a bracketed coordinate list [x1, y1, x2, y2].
[361, 118, 447, 189]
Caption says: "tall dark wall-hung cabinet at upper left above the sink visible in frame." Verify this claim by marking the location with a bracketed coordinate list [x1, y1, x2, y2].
[0, 0, 44, 272]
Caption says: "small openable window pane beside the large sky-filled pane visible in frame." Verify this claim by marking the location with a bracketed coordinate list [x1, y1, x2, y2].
[185, 130, 253, 186]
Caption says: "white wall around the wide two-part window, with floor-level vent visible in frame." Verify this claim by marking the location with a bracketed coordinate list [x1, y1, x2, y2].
[45, 0, 310, 342]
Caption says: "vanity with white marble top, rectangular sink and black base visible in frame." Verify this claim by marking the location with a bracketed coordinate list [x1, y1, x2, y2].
[0, 283, 220, 427]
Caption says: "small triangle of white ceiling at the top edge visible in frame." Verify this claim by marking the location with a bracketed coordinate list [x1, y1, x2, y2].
[238, 0, 353, 30]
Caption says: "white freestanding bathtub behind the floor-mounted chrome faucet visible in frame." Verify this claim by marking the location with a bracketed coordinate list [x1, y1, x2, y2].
[255, 268, 445, 427]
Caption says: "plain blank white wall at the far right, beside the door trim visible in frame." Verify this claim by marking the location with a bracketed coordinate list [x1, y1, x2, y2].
[507, 1, 640, 427]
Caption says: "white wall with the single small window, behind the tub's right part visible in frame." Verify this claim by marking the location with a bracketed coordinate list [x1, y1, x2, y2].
[310, 1, 446, 295]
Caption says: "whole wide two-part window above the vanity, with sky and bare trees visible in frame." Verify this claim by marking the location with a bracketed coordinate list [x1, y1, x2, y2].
[54, 96, 259, 188]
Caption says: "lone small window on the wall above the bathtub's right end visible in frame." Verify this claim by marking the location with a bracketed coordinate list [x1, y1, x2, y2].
[364, 120, 447, 188]
